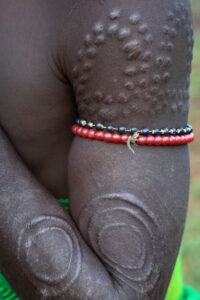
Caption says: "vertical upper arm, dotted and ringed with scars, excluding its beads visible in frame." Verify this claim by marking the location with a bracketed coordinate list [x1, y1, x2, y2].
[63, 1, 192, 299]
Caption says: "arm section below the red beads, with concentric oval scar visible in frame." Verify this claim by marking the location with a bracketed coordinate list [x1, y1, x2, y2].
[69, 137, 189, 300]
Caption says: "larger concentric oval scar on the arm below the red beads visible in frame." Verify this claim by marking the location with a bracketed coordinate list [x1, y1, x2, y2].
[79, 194, 165, 293]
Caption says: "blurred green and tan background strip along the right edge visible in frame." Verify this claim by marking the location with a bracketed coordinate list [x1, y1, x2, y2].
[182, 0, 200, 292]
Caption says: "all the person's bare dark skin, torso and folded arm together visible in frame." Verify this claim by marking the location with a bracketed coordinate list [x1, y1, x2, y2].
[0, 0, 193, 300]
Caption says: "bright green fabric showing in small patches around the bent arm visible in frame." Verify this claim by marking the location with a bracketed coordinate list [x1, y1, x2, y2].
[0, 199, 200, 300]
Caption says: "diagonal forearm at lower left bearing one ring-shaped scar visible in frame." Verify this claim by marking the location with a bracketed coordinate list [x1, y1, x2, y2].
[0, 132, 118, 300]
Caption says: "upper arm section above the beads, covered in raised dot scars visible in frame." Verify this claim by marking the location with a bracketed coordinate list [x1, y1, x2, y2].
[63, 0, 193, 127]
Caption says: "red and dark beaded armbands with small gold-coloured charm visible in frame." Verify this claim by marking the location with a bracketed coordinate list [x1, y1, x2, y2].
[72, 119, 194, 152]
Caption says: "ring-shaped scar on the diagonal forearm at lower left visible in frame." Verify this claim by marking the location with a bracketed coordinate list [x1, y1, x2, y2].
[18, 216, 81, 297]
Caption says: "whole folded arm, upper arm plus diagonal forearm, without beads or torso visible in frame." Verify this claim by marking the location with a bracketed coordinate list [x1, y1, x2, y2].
[0, 0, 192, 300]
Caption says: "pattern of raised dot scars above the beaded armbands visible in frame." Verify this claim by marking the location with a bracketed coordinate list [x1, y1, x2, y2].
[72, 0, 193, 122]
